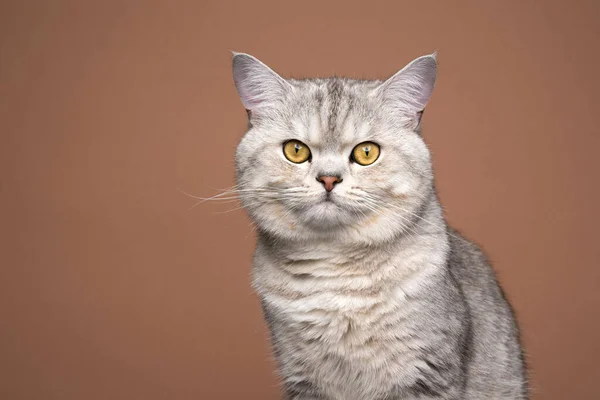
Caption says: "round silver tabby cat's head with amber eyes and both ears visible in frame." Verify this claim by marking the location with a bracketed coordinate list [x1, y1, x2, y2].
[233, 53, 437, 243]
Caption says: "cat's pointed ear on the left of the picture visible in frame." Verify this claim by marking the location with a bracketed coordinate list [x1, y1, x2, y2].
[233, 52, 292, 112]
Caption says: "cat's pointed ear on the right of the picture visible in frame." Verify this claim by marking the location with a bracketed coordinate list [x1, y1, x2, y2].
[375, 52, 437, 126]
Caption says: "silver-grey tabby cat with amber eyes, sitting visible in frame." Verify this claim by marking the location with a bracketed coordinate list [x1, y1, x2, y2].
[233, 52, 528, 400]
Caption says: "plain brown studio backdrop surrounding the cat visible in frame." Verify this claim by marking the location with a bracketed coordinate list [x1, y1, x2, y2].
[0, 0, 600, 400]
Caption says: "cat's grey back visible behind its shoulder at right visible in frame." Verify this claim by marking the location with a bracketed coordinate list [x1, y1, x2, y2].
[448, 229, 527, 399]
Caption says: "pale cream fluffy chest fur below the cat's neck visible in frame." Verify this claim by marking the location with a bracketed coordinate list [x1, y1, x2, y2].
[254, 253, 440, 399]
